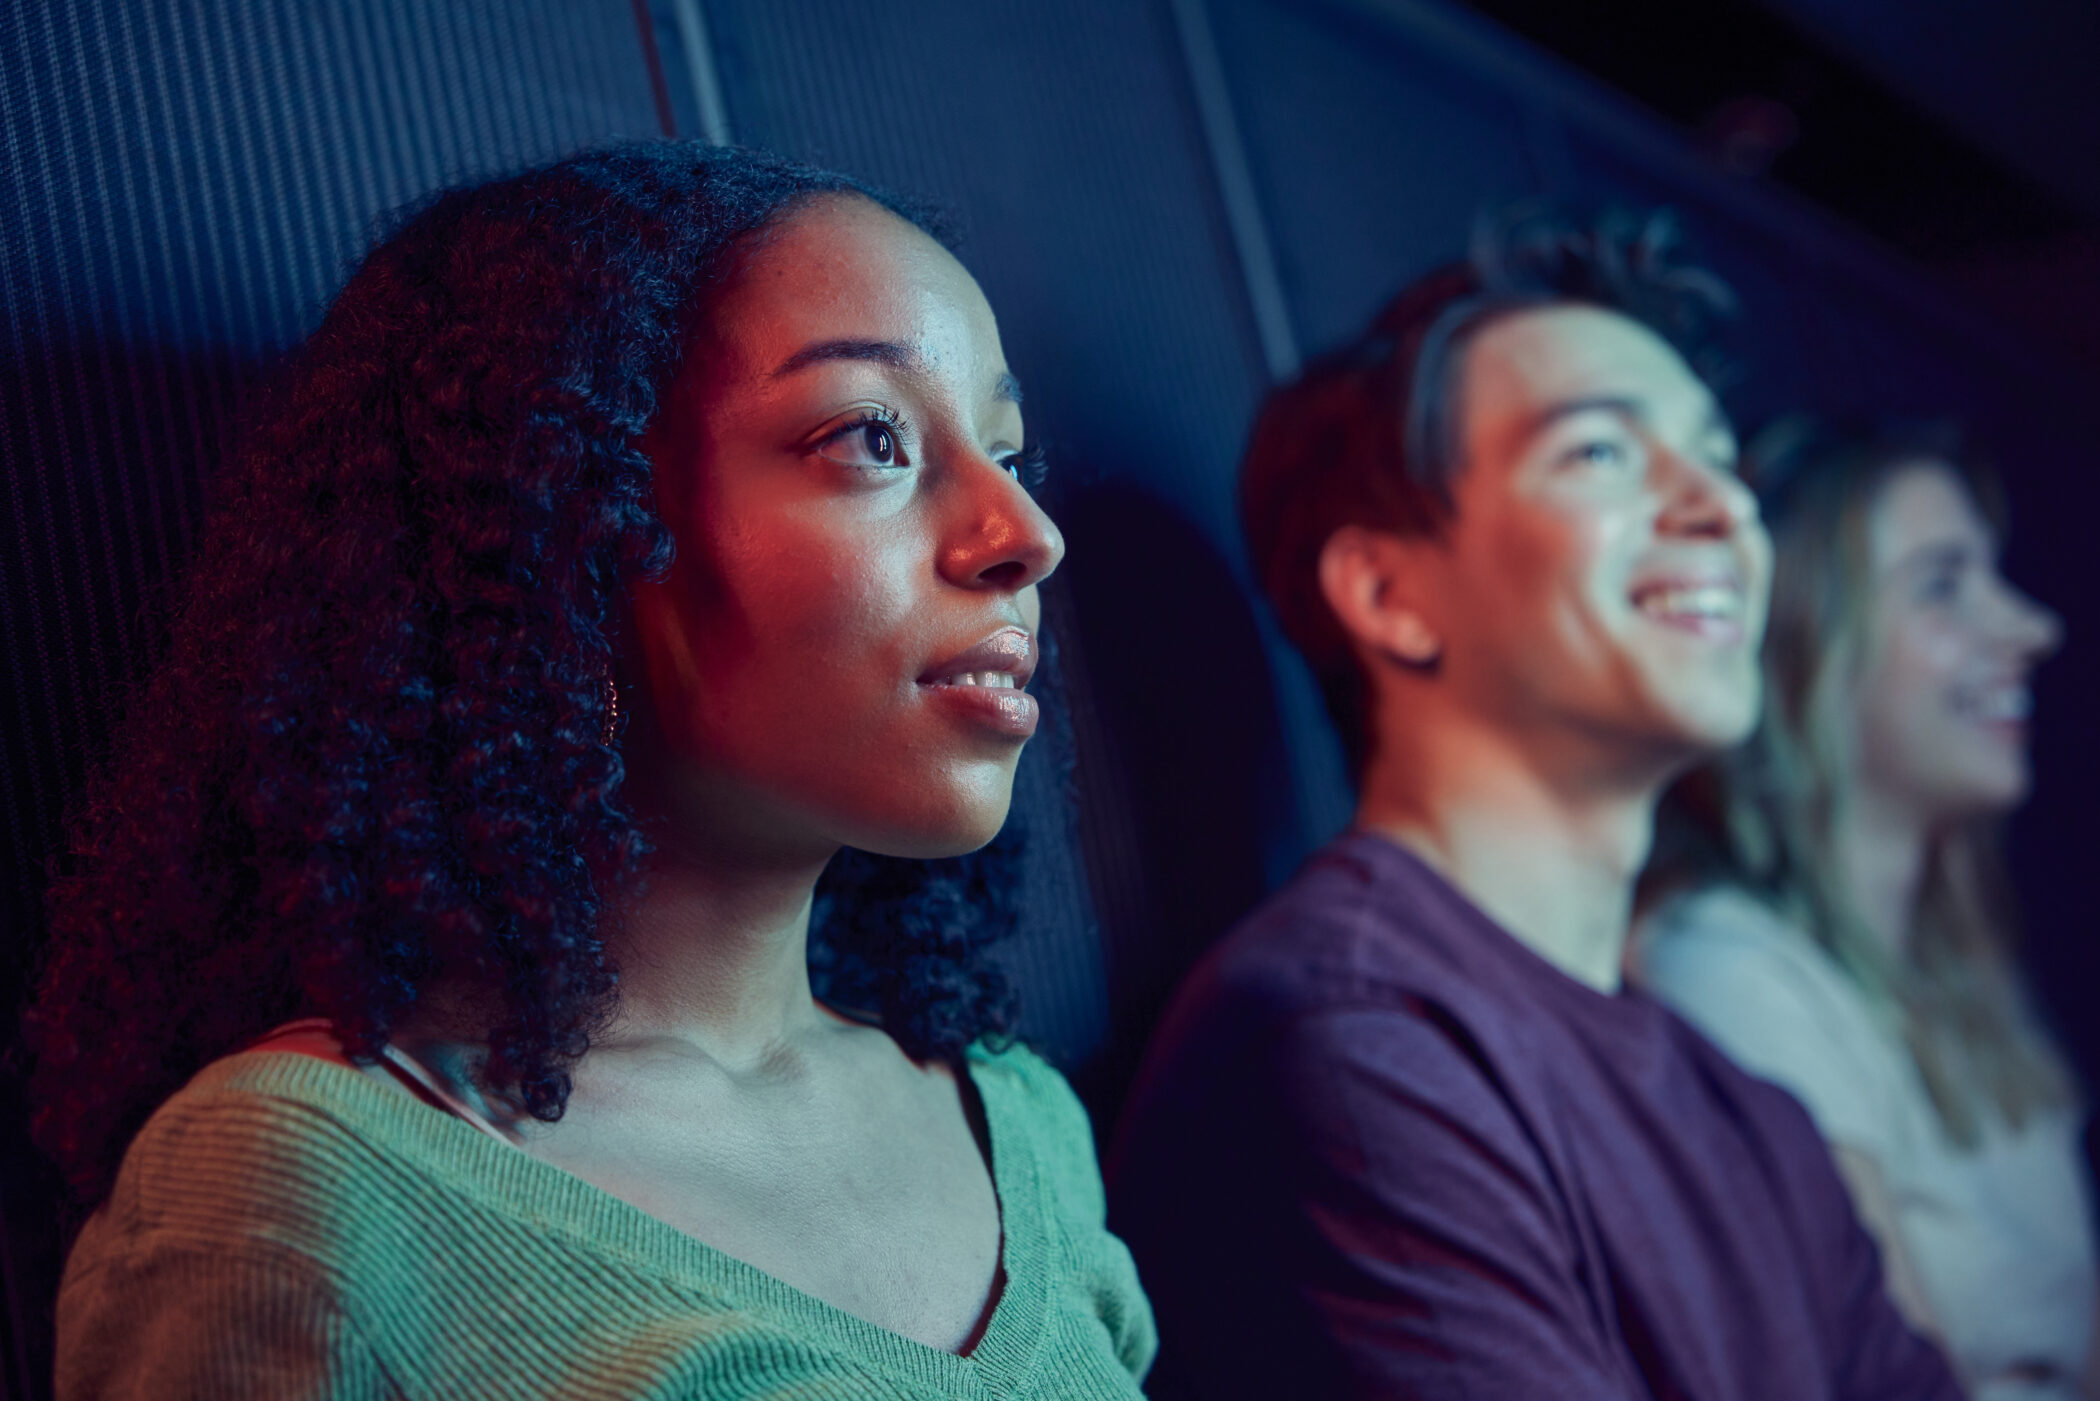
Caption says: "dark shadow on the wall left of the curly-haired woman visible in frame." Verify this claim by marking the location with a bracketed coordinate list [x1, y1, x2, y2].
[0, 336, 269, 1397]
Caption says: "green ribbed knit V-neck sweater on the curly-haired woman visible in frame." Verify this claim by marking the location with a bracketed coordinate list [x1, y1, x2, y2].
[59, 1048, 1155, 1401]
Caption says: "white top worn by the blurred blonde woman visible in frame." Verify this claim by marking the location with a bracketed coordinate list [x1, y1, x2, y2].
[1634, 888, 2094, 1401]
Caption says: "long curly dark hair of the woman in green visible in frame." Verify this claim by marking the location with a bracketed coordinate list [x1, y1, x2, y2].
[25, 143, 1019, 1204]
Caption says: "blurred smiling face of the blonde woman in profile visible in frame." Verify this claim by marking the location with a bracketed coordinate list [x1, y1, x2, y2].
[1854, 462, 2062, 821]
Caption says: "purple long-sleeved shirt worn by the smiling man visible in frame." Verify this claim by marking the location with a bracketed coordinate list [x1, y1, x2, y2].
[1109, 834, 1959, 1401]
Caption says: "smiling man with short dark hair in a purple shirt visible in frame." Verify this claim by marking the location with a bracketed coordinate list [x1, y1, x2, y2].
[1111, 211, 1959, 1401]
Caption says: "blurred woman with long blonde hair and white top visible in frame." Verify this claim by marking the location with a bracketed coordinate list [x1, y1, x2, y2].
[1640, 424, 2094, 1397]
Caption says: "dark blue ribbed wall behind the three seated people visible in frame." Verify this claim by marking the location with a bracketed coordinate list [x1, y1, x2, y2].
[0, 0, 2100, 1395]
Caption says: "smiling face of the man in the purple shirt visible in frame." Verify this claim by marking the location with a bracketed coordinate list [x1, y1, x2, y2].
[1426, 305, 1770, 762]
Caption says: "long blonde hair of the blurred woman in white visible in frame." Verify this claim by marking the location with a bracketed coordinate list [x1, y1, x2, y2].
[1646, 420, 2073, 1145]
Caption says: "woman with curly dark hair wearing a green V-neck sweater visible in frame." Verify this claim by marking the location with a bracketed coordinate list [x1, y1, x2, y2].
[29, 145, 1153, 1397]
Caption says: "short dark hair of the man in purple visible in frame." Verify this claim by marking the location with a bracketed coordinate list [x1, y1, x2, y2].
[1239, 208, 1735, 775]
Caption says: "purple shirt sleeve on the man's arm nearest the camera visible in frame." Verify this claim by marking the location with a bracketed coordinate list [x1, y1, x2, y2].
[1256, 1008, 1646, 1401]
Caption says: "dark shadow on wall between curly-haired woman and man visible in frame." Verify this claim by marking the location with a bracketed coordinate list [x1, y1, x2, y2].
[1058, 477, 1294, 1126]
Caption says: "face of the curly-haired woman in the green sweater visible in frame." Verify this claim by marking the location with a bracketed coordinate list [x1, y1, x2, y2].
[630, 195, 1065, 859]
